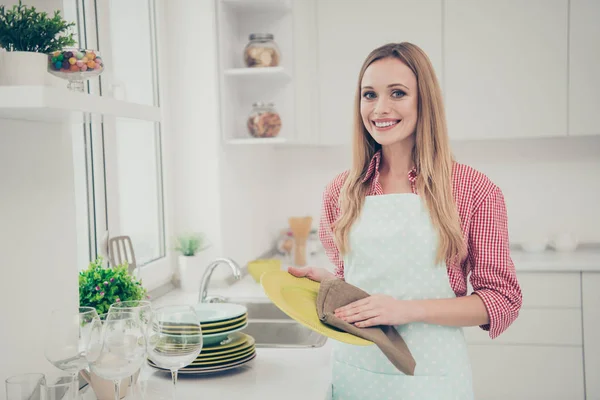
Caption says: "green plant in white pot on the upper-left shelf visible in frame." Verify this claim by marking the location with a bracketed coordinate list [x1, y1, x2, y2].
[0, 0, 76, 85]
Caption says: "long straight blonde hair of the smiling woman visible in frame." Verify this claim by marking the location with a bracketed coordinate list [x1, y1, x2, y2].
[333, 42, 465, 263]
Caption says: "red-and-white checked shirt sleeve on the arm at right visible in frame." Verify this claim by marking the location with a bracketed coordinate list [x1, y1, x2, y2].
[468, 187, 523, 339]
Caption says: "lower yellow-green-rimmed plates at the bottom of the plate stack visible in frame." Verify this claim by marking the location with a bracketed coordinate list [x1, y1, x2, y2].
[148, 332, 256, 374]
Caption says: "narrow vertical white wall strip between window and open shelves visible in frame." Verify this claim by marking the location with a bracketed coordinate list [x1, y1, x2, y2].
[159, 1, 230, 278]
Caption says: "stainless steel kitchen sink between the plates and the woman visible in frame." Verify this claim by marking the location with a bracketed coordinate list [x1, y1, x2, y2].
[230, 299, 327, 348]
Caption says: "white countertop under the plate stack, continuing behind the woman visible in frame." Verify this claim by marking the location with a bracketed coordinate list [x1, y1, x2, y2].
[135, 245, 600, 400]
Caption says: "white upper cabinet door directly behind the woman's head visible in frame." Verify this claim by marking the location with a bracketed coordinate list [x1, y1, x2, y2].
[317, 0, 442, 144]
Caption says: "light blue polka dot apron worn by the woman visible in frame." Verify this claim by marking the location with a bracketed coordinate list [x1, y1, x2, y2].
[332, 193, 474, 400]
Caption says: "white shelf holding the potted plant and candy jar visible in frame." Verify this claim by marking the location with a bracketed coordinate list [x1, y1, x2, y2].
[0, 86, 161, 123]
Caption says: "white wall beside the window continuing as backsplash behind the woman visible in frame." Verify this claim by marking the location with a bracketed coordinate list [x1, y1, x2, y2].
[165, 1, 600, 272]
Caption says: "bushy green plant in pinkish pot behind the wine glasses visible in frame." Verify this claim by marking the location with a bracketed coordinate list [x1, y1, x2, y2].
[79, 257, 148, 400]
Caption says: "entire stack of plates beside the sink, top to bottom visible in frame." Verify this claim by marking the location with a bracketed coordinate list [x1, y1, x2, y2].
[148, 303, 256, 374]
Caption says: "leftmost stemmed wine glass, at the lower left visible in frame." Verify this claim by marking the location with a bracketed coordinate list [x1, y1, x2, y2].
[45, 307, 102, 399]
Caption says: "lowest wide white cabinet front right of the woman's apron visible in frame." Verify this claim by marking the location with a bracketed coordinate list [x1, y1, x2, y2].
[469, 345, 590, 400]
